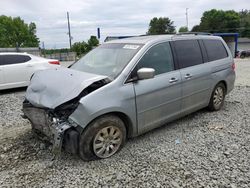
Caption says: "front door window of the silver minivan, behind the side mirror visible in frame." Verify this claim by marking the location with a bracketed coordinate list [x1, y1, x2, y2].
[136, 42, 174, 75]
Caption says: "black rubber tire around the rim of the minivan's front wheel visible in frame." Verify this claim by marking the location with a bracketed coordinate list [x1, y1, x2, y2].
[79, 115, 126, 161]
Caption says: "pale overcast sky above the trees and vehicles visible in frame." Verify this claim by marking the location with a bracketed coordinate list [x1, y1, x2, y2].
[0, 0, 250, 48]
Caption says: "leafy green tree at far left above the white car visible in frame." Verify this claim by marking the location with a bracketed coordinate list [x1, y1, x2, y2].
[0, 15, 39, 48]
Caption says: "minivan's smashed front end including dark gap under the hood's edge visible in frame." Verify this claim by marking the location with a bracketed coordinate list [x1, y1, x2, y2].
[23, 67, 111, 155]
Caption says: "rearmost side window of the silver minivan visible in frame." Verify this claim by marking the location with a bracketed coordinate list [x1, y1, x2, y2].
[203, 40, 228, 61]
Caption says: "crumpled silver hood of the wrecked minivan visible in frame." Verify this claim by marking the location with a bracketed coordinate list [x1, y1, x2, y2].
[26, 67, 107, 109]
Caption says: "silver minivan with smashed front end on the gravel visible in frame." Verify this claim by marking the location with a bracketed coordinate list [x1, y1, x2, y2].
[23, 35, 235, 160]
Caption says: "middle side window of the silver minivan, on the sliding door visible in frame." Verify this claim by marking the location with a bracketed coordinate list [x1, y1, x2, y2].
[174, 40, 203, 68]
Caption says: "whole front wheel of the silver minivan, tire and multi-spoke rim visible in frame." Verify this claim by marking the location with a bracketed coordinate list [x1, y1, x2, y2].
[79, 115, 126, 161]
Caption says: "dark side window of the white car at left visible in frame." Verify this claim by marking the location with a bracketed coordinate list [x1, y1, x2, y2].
[1, 55, 31, 65]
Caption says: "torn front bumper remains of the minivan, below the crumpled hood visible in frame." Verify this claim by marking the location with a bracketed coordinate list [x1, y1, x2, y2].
[23, 101, 79, 155]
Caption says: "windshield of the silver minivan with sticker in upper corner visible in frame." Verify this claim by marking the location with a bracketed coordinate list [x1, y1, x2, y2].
[70, 43, 142, 79]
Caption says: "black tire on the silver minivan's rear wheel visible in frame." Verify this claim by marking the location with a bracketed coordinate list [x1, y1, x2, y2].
[208, 82, 226, 111]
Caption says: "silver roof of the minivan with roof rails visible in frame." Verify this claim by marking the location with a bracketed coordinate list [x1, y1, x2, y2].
[105, 34, 221, 44]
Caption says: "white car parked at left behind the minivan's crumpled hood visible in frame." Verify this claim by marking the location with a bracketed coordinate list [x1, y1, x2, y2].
[0, 53, 60, 90]
